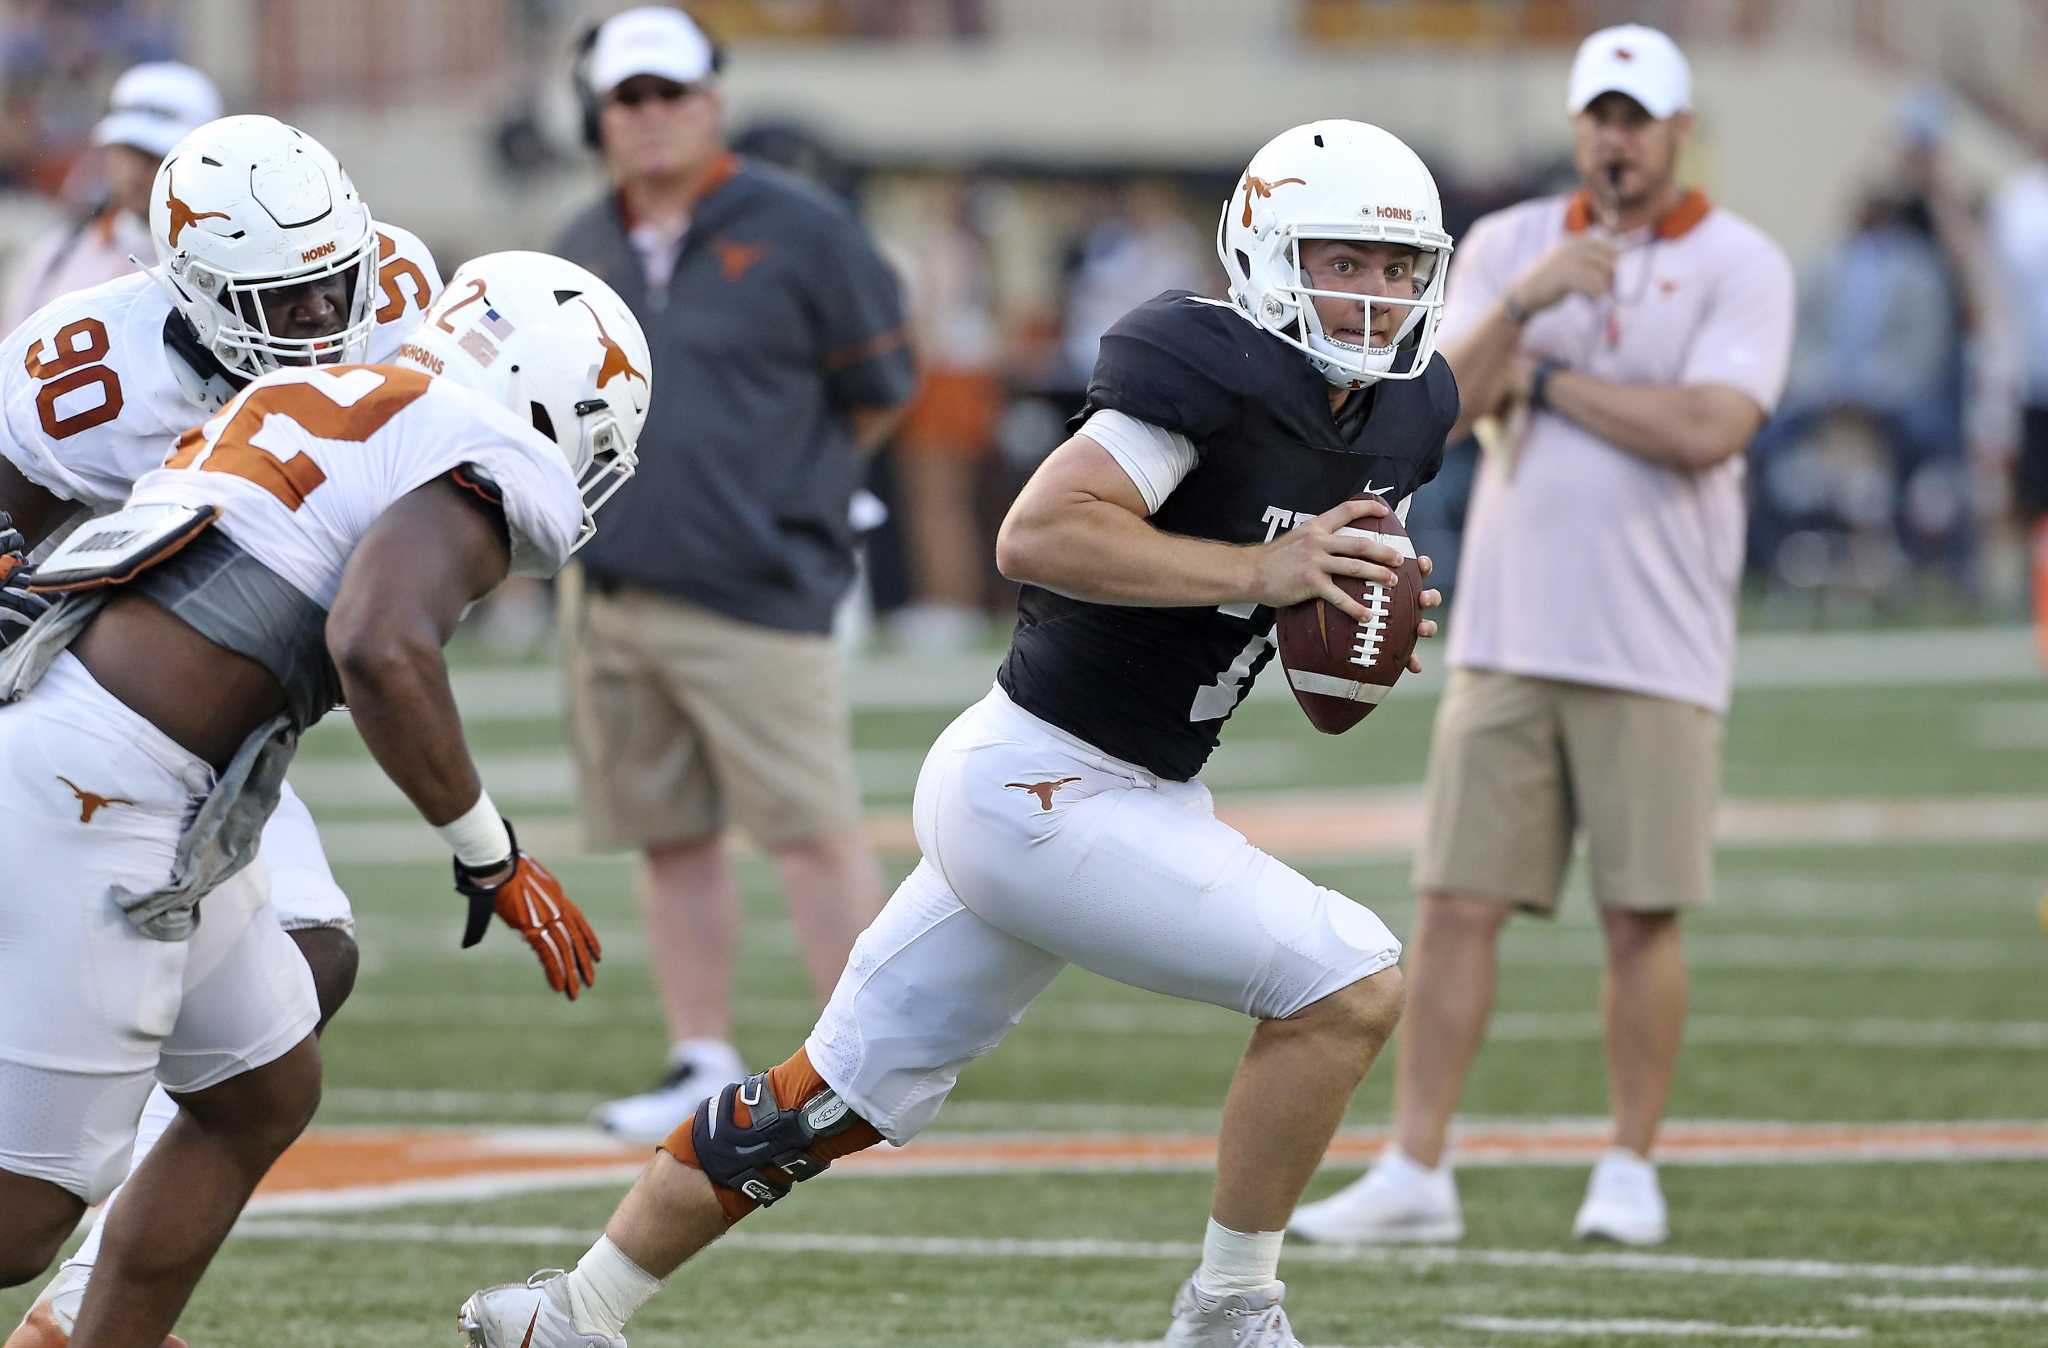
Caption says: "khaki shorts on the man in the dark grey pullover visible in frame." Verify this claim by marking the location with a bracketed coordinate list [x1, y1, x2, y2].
[561, 570, 860, 848]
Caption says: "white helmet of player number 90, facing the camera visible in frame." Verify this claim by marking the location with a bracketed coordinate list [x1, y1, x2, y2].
[150, 115, 377, 379]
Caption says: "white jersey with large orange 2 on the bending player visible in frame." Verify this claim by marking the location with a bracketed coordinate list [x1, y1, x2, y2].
[129, 365, 584, 608]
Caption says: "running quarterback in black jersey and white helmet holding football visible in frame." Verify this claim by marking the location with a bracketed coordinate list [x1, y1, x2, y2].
[463, 121, 1458, 1348]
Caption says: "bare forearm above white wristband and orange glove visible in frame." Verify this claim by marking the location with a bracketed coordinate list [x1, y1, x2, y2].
[334, 633, 483, 826]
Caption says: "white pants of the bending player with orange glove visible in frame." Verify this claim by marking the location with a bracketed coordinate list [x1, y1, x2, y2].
[0, 654, 319, 1203]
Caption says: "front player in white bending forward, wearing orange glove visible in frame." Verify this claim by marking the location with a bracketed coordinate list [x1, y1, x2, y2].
[0, 252, 651, 1348]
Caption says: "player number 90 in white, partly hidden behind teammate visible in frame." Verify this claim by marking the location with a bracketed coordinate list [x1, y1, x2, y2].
[0, 117, 440, 1348]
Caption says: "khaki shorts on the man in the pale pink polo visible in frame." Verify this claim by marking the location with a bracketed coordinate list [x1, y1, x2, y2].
[1415, 668, 1722, 914]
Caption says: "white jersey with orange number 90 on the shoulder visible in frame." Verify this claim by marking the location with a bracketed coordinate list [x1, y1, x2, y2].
[0, 225, 440, 514]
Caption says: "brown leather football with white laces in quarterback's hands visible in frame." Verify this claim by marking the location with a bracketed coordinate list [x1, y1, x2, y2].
[1274, 487, 1423, 735]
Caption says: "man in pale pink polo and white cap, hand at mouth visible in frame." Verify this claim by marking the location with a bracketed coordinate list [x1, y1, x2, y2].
[1288, 25, 1794, 1246]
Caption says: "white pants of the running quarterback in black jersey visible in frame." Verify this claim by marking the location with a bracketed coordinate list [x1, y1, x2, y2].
[805, 688, 1401, 1145]
